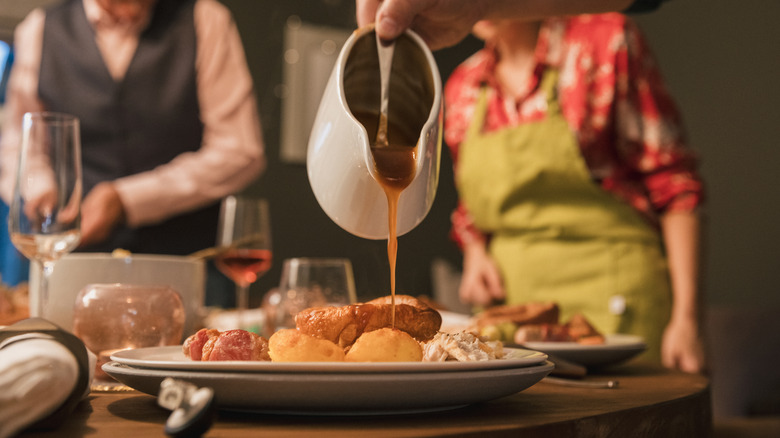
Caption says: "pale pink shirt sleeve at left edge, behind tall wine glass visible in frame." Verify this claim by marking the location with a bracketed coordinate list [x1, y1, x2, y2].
[0, 9, 46, 204]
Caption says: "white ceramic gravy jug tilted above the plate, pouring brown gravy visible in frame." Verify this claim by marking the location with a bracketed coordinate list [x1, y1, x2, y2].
[307, 27, 442, 239]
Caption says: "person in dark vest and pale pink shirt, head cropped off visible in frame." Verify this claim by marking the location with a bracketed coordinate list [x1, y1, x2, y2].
[0, 0, 265, 304]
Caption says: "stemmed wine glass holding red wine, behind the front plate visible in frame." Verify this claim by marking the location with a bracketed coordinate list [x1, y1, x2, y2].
[215, 196, 272, 327]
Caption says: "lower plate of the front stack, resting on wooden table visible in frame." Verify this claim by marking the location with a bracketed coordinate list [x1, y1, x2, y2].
[102, 361, 554, 415]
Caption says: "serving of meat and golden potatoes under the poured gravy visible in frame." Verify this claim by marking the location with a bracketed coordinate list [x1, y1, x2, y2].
[182, 295, 504, 362]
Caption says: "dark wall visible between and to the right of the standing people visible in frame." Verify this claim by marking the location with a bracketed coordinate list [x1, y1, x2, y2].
[222, 0, 780, 305]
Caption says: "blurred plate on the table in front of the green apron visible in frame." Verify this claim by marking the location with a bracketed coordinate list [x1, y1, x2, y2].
[522, 334, 647, 367]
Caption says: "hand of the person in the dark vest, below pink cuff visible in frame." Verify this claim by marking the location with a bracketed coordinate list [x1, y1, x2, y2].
[79, 182, 125, 247]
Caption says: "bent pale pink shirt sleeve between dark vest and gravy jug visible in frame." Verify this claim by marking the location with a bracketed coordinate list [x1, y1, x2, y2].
[115, 0, 265, 226]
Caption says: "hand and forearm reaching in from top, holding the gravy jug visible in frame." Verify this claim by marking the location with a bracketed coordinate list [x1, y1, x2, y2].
[355, 0, 666, 50]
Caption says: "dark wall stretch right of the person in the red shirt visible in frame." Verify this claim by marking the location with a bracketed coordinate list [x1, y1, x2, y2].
[639, 0, 780, 308]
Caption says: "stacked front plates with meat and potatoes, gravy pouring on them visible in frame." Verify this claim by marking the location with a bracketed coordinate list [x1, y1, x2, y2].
[102, 296, 554, 415]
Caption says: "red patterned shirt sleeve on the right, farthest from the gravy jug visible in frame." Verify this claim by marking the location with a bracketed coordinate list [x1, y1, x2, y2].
[615, 20, 704, 213]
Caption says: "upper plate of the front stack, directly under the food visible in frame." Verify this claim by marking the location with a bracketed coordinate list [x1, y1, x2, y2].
[111, 346, 547, 373]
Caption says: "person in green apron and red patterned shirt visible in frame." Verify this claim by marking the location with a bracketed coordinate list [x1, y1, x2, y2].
[445, 14, 705, 372]
